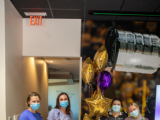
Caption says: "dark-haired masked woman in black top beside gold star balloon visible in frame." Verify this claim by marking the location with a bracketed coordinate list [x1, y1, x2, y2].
[102, 98, 127, 120]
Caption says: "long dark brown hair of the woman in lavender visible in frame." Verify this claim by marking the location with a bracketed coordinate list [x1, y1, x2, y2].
[55, 92, 71, 115]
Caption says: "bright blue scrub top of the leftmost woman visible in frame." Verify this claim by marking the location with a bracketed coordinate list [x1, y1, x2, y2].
[19, 109, 43, 120]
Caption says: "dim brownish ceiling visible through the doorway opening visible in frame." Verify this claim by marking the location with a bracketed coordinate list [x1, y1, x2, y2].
[44, 58, 80, 80]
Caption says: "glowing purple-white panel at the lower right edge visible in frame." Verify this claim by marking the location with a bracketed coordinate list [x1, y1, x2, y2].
[155, 85, 160, 120]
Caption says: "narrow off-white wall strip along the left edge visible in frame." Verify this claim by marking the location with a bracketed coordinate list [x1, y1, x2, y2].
[0, 0, 6, 120]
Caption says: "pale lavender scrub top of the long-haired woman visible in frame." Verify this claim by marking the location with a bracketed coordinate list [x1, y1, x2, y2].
[47, 108, 73, 120]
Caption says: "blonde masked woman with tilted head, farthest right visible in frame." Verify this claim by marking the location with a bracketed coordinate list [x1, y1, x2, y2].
[125, 103, 149, 120]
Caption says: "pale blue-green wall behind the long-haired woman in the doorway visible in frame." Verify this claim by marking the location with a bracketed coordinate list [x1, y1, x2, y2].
[48, 83, 80, 120]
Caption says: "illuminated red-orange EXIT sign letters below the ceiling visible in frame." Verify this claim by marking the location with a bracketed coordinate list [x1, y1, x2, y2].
[30, 16, 42, 25]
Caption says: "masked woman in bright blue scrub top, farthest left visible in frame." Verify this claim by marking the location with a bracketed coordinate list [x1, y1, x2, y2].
[19, 92, 43, 120]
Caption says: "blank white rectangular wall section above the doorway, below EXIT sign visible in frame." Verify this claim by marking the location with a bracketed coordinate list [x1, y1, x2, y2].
[23, 19, 81, 57]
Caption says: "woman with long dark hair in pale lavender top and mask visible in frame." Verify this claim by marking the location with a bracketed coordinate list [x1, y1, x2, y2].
[47, 92, 73, 120]
